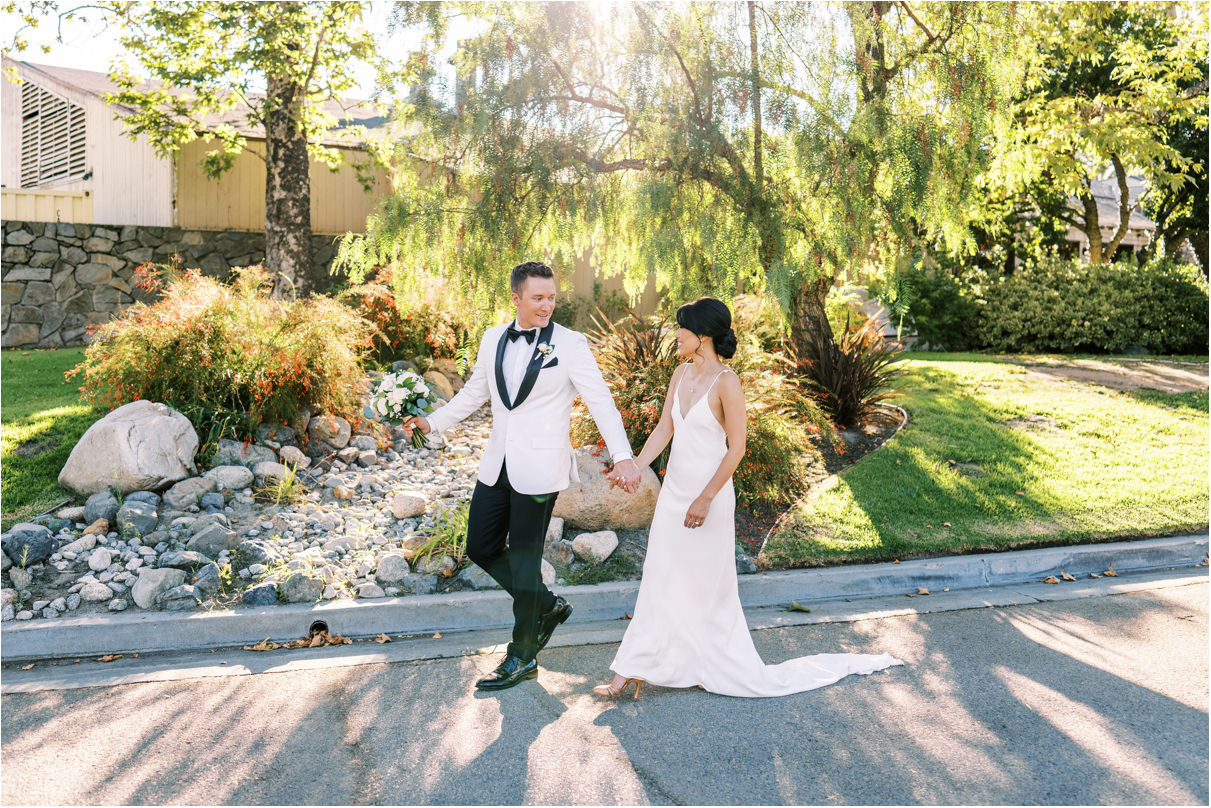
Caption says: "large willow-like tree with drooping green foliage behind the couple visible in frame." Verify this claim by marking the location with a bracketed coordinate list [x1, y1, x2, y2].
[340, 2, 1014, 348]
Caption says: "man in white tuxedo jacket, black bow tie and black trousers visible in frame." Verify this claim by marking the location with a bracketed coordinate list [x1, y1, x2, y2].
[403, 262, 641, 690]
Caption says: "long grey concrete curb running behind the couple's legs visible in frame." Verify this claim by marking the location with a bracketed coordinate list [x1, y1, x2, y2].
[0, 533, 1207, 663]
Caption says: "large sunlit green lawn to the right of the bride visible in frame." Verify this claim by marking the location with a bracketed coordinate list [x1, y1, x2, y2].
[762, 354, 1209, 567]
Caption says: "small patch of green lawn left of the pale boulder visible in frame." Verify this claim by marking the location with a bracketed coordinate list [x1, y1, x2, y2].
[0, 348, 103, 529]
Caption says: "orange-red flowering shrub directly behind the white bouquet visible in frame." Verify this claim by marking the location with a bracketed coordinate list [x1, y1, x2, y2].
[338, 267, 470, 365]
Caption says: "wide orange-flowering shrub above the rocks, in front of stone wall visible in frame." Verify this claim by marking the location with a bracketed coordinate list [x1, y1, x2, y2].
[67, 264, 373, 426]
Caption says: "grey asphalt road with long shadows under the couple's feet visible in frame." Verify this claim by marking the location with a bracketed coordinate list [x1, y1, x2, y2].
[0, 584, 1209, 806]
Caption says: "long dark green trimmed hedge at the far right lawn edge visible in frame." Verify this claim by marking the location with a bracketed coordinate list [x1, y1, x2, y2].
[972, 257, 1207, 354]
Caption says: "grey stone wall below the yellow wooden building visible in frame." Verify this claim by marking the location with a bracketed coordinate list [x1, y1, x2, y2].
[0, 222, 337, 348]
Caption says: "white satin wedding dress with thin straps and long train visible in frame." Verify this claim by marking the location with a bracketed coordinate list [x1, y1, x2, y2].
[610, 371, 903, 697]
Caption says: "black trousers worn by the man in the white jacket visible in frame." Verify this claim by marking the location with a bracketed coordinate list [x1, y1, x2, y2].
[466, 465, 558, 659]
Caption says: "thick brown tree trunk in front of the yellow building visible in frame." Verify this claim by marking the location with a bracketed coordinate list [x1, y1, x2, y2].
[265, 76, 314, 296]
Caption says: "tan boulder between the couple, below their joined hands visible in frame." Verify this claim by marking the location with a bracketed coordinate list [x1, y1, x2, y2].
[553, 447, 660, 531]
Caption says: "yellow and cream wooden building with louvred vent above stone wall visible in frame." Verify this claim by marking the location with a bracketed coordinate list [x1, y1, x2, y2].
[0, 57, 391, 235]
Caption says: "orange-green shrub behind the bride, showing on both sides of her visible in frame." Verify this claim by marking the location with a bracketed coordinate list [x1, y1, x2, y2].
[573, 307, 836, 504]
